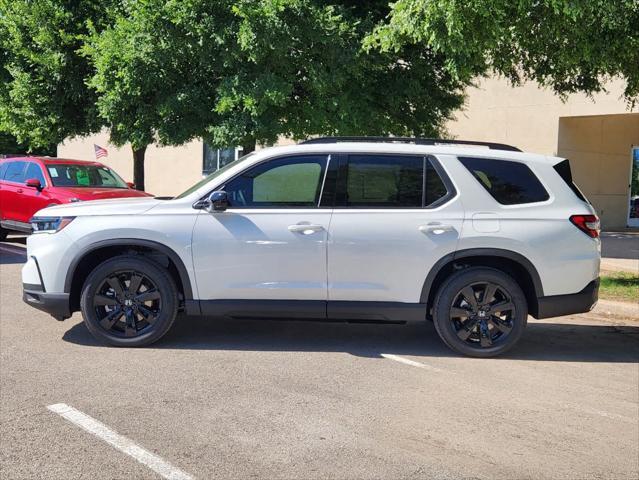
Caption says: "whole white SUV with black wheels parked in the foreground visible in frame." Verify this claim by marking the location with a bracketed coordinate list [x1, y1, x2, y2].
[22, 138, 600, 357]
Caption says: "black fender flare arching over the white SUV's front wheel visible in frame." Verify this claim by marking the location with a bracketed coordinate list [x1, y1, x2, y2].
[64, 238, 193, 300]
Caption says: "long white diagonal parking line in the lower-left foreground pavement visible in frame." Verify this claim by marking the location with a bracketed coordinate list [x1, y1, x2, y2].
[47, 403, 193, 480]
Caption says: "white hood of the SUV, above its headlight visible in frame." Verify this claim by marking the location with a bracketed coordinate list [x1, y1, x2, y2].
[35, 197, 162, 217]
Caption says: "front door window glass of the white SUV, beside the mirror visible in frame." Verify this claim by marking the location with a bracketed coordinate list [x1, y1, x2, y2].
[224, 155, 327, 208]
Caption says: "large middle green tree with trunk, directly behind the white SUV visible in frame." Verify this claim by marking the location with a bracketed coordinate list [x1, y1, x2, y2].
[84, 0, 465, 188]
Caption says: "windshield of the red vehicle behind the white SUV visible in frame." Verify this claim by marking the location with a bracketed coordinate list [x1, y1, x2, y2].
[47, 163, 129, 188]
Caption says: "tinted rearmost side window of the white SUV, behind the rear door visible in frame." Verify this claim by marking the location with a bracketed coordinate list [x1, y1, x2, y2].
[459, 157, 549, 205]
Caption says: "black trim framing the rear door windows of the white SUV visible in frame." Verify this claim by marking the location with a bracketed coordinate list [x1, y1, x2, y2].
[334, 150, 457, 211]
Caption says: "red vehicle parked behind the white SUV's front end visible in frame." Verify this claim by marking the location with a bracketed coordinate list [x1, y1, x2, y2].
[0, 157, 150, 240]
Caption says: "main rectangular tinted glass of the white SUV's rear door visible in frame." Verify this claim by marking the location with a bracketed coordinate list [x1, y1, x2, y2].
[345, 155, 424, 208]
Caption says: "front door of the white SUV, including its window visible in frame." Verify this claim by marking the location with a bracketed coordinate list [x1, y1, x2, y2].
[193, 155, 332, 318]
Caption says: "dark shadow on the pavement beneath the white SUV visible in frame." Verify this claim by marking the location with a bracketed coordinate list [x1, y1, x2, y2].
[63, 316, 639, 363]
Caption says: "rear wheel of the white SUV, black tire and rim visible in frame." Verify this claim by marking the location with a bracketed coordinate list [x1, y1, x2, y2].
[433, 267, 528, 358]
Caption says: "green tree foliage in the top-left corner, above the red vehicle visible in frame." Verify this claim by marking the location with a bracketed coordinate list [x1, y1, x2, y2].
[0, 0, 115, 149]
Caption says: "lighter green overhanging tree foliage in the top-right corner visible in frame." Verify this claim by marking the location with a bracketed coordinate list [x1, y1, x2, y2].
[366, 0, 639, 104]
